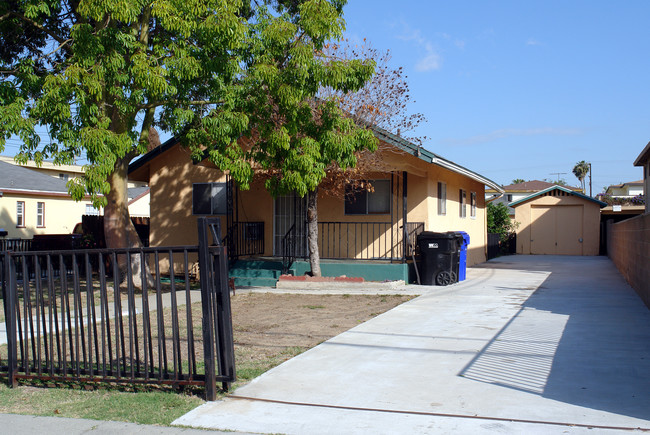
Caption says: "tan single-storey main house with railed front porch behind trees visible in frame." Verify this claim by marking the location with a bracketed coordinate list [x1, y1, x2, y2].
[129, 128, 501, 279]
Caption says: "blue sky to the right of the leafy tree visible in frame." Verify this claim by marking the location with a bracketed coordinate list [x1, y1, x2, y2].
[344, 0, 650, 194]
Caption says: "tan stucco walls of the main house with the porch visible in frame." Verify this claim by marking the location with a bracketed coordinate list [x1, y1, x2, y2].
[138, 143, 486, 265]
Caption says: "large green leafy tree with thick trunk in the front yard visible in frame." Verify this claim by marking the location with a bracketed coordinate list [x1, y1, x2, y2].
[0, 0, 374, 280]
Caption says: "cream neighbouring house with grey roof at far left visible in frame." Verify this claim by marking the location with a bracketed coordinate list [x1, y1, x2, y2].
[0, 161, 92, 239]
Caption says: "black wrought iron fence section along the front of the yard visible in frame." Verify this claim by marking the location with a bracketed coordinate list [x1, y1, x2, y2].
[0, 218, 235, 400]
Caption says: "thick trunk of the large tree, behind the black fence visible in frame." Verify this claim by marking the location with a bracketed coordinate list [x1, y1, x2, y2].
[104, 159, 153, 288]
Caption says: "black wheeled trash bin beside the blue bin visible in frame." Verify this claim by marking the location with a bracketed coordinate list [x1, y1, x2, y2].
[418, 231, 460, 285]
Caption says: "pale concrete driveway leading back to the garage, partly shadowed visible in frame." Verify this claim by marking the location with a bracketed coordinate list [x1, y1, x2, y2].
[174, 256, 650, 434]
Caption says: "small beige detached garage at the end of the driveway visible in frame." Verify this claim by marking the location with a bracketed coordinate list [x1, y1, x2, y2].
[509, 186, 607, 255]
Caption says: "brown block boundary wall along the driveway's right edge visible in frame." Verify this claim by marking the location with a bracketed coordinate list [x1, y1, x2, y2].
[607, 214, 650, 308]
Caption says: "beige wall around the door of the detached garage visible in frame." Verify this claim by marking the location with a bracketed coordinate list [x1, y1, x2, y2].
[515, 195, 600, 255]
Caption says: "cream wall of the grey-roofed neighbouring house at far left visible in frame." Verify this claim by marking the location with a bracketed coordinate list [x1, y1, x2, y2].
[0, 192, 90, 239]
